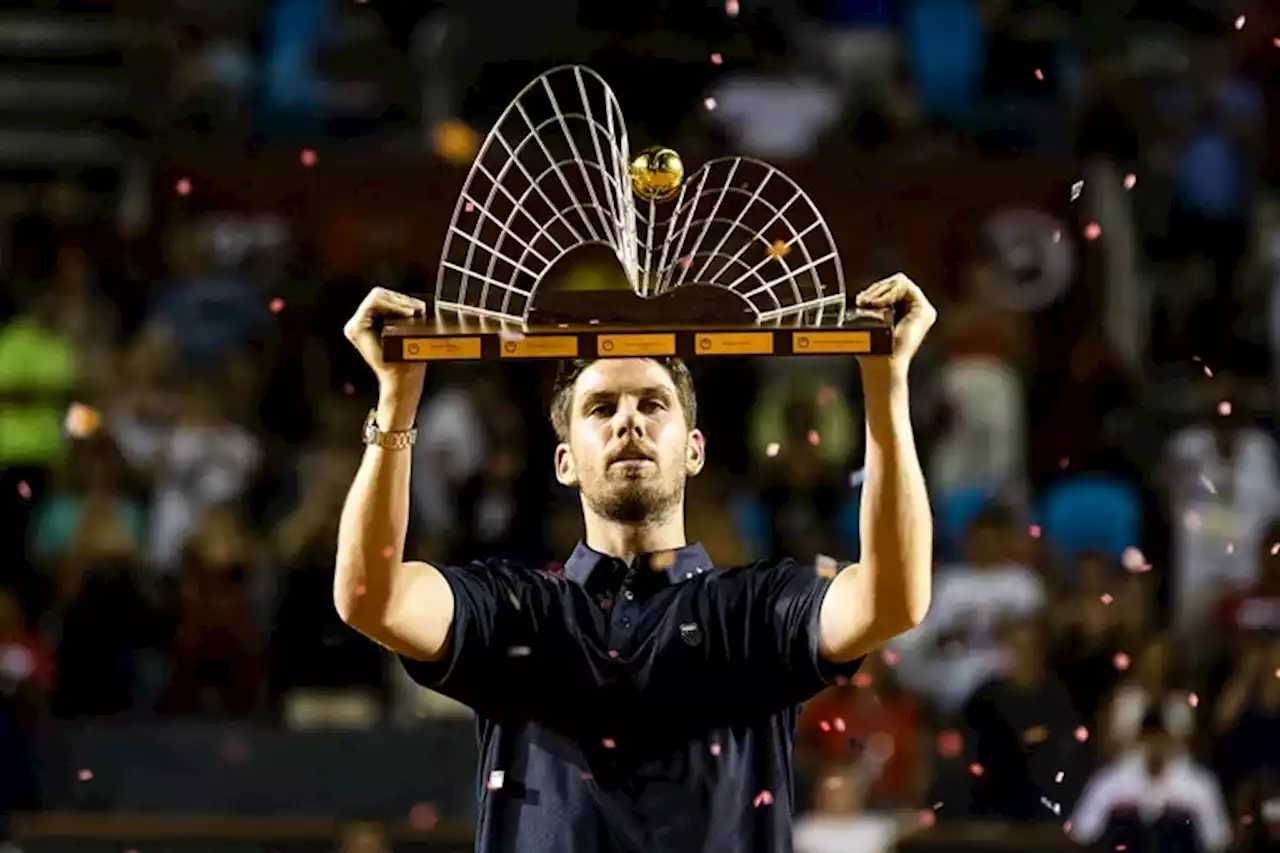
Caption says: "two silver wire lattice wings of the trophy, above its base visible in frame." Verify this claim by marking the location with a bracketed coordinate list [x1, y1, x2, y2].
[435, 65, 845, 325]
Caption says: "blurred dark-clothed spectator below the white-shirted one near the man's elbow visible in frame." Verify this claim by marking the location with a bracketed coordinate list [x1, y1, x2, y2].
[964, 620, 1079, 822]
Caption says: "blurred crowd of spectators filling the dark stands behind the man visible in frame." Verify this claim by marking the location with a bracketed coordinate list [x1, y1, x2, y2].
[0, 0, 1280, 853]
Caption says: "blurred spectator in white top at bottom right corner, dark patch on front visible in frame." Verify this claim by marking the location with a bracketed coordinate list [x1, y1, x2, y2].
[1070, 713, 1231, 853]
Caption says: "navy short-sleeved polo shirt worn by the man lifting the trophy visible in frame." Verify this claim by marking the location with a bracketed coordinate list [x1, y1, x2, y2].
[404, 544, 860, 853]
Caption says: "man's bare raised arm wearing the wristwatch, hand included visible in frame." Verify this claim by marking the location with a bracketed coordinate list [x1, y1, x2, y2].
[333, 288, 453, 661]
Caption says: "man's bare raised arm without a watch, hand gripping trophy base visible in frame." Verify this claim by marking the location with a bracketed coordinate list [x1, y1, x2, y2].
[819, 275, 937, 663]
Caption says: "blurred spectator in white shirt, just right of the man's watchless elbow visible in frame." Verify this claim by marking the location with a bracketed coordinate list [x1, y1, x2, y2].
[900, 507, 1044, 712]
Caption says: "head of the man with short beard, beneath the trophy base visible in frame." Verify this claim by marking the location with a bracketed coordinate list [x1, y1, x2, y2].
[556, 359, 704, 524]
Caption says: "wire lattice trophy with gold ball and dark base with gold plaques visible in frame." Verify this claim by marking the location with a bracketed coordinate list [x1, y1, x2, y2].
[383, 65, 892, 361]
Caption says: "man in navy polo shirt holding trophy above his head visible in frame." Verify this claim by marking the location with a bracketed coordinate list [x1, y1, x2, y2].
[334, 275, 937, 853]
